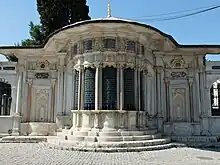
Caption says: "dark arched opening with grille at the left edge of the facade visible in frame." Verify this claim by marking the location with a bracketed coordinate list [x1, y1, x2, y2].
[0, 78, 12, 116]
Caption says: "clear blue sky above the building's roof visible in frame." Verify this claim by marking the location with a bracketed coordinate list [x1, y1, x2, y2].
[0, 0, 220, 60]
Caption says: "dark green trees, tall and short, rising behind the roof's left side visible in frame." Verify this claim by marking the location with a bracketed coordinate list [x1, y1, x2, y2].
[6, 0, 91, 61]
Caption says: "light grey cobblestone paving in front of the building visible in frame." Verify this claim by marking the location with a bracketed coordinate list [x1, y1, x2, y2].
[0, 143, 220, 165]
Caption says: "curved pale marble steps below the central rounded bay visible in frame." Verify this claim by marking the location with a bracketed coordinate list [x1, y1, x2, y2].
[45, 129, 173, 152]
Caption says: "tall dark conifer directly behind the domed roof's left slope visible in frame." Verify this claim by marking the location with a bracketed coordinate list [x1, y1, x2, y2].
[37, 0, 91, 36]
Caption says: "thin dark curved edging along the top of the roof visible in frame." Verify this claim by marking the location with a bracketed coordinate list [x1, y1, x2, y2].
[0, 18, 220, 49]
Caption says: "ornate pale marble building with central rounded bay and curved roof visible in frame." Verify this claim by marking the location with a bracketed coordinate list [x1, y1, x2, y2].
[0, 13, 220, 148]
